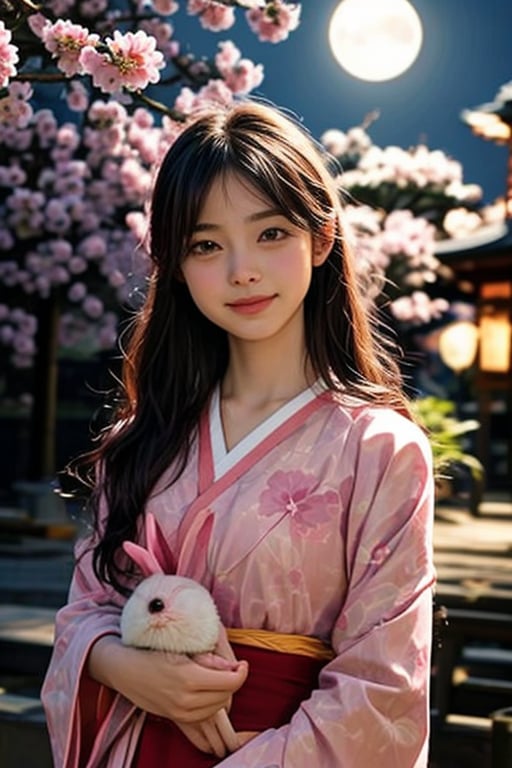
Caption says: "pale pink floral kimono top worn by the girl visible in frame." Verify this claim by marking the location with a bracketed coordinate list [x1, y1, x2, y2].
[42, 390, 435, 768]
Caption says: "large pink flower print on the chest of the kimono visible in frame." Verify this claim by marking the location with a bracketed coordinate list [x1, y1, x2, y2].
[259, 470, 338, 536]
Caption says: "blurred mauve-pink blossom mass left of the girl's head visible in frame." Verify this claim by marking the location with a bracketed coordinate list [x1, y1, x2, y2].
[0, 101, 153, 367]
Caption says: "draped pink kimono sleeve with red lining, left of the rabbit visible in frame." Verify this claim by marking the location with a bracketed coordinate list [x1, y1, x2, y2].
[41, 504, 133, 768]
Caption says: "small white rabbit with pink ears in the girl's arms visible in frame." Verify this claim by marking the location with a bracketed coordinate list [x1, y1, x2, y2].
[121, 514, 239, 756]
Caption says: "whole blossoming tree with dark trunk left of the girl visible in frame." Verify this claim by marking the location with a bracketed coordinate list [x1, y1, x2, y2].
[0, 0, 300, 480]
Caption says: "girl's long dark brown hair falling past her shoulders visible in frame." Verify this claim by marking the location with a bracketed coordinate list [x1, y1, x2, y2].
[76, 102, 408, 591]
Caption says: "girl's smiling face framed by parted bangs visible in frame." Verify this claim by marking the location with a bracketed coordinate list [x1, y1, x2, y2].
[182, 173, 330, 350]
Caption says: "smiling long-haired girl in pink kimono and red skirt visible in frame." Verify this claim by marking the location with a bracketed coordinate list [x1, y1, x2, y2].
[42, 103, 434, 768]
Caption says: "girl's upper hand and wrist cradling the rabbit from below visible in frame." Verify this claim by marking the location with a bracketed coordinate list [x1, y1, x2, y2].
[89, 635, 248, 725]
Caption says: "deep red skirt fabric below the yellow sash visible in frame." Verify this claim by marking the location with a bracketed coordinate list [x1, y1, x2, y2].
[134, 643, 325, 768]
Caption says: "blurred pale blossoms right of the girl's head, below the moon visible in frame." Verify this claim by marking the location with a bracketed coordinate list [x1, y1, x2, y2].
[321, 121, 502, 328]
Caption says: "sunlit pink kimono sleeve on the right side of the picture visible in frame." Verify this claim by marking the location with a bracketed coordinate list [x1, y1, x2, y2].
[219, 413, 435, 768]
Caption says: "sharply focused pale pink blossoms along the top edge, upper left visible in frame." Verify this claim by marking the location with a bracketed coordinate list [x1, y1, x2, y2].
[0, 0, 301, 94]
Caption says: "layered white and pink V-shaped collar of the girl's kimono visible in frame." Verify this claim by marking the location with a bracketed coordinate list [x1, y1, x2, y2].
[199, 383, 325, 493]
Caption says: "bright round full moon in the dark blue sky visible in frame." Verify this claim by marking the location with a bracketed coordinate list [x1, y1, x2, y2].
[329, 0, 423, 82]
